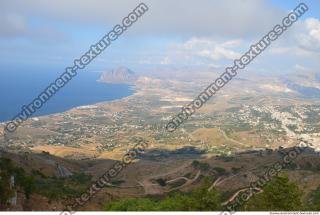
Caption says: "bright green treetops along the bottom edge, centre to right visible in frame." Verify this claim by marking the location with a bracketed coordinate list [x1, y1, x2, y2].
[104, 176, 320, 211]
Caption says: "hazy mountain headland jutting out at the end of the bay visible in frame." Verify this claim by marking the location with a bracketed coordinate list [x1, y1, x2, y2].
[99, 67, 138, 84]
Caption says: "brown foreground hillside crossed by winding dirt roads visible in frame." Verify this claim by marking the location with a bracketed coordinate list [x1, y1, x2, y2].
[1, 148, 320, 210]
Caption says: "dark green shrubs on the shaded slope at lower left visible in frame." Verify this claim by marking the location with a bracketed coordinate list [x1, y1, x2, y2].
[0, 155, 91, 204]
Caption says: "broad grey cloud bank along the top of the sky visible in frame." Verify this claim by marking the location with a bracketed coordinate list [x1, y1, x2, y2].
[0, 0, 284, 37]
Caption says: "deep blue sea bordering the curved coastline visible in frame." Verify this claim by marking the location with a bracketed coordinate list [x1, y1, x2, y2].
[0, 69, 133, 121]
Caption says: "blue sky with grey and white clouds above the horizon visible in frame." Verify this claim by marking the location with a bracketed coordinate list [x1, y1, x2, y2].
[0, 0, 320, 73]
